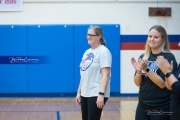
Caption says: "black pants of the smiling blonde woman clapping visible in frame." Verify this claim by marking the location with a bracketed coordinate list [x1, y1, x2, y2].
[135, 103, 170, 120]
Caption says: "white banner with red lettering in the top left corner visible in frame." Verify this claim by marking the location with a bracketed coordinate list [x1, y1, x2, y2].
[0, 0, 22, 11]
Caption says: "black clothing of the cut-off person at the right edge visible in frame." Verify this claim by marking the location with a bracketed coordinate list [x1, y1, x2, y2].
[170, 64, 180, 120]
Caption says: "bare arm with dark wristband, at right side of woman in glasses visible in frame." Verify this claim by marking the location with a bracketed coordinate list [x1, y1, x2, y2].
[96, 67, 111, 109]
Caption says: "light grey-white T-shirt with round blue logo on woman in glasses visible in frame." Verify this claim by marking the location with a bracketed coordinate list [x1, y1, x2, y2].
[80, 45, 112, 97]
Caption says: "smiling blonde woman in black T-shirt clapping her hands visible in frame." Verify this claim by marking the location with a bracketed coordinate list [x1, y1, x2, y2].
[131, 25, 177, 120]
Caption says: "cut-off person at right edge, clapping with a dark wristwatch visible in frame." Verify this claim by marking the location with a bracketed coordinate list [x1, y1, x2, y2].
[156, 42, 180, 120]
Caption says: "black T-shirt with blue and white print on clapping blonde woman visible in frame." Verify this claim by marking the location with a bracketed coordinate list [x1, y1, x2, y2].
[139, 52, 177, 109]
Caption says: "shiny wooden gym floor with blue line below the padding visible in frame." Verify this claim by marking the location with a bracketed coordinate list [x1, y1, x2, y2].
[0, 97, 138, 120]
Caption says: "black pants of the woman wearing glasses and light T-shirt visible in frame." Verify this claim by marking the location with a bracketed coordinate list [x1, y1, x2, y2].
[81, 96, 108, 120]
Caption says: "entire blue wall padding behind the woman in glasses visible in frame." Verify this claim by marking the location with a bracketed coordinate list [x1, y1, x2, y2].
[0, 24, 120, 93]
